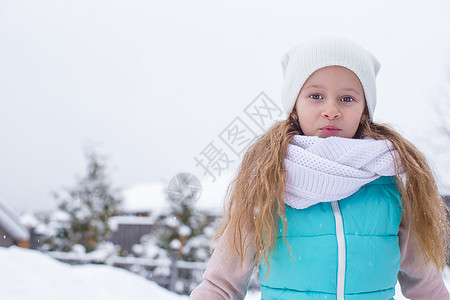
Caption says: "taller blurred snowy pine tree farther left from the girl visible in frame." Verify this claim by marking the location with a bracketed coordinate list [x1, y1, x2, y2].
[45, 145, 121, 252]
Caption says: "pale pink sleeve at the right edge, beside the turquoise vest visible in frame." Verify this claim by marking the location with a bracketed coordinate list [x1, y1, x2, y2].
[397, 217, 450, 300]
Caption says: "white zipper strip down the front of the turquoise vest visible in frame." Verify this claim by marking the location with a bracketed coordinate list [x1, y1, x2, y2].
[331, 201, 345, 300]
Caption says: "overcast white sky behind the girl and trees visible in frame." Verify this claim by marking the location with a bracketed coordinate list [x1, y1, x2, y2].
[0, 0, 450, 213]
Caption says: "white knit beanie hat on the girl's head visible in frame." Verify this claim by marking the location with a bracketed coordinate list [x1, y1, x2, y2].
[281, 37, 381, 119]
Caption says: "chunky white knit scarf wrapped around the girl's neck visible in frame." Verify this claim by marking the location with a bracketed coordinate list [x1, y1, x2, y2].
[283, 135, 398, 209]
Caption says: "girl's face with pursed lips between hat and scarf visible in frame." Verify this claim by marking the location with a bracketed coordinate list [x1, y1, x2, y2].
[295, 66, 366, 138]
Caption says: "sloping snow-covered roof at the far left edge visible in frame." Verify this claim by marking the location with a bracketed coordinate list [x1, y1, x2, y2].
[0, 199, 30, 240]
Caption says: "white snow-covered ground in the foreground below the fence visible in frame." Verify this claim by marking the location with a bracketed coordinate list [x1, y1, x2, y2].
[0, 246, 450, 300]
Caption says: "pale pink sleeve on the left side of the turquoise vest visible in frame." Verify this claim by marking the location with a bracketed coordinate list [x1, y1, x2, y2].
[189, 229, 255, 300]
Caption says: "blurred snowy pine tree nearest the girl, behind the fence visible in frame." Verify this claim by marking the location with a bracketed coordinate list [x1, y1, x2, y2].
[133, 173, 215, 294]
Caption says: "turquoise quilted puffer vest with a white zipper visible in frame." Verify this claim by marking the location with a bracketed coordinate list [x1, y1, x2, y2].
[259, 177, 402, 300]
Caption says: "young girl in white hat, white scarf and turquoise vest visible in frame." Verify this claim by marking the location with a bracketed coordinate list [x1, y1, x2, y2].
[190, 38, 450, 300]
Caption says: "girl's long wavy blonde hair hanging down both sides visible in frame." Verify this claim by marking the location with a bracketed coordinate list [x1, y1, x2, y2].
[214, 108, 450, 274]
